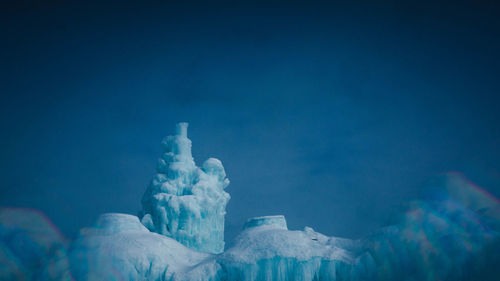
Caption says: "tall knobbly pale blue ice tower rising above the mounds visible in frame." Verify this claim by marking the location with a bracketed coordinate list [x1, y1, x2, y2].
[141, 123, 230, 253]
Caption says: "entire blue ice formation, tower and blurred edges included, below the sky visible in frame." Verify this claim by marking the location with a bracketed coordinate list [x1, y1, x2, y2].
[0, 123, 500, 281]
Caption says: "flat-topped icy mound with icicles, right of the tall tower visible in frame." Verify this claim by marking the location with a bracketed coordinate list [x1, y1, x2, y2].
[218, 216, 374, 281]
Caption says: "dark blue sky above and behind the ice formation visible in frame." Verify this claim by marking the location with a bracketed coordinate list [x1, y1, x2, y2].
[0, 1, 500, 239]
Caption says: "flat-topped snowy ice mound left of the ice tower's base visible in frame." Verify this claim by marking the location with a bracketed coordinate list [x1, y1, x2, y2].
[70, 214, 209, 281]
